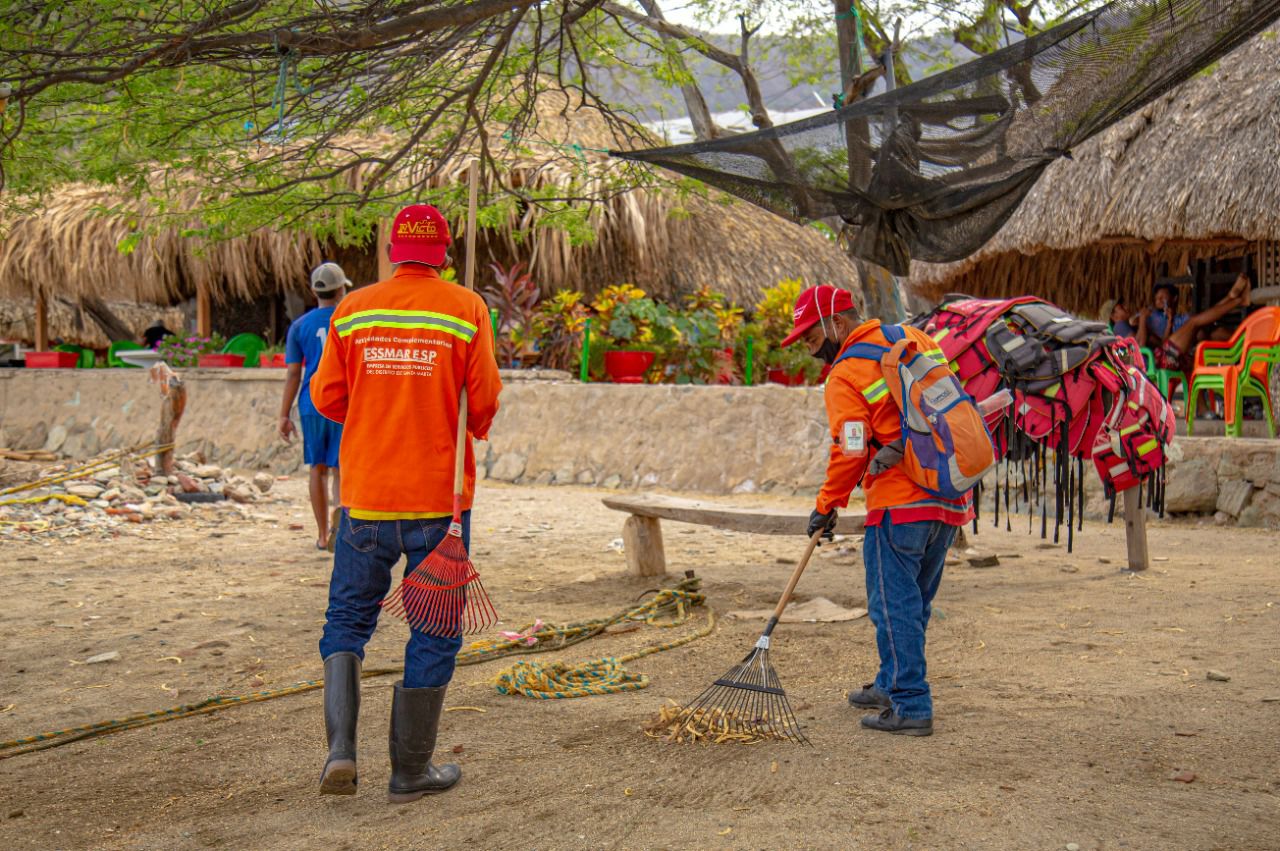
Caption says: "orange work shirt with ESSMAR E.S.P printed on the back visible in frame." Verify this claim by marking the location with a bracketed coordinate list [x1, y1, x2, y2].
[311, 264, 502, 514]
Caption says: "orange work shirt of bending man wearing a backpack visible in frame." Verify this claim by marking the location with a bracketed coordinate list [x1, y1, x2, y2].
[814, 319, 973, 526]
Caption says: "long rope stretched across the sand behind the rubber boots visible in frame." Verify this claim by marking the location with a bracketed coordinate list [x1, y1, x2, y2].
[0, 578, 712, 760]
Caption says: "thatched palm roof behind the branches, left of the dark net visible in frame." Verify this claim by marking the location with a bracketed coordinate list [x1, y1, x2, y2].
[0, 95, 858, 310]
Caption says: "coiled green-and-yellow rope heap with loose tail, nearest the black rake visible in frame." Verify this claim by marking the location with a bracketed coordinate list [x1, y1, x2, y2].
[493, 613, 716, 700]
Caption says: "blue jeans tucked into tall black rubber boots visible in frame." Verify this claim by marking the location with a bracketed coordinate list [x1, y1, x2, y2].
[320, 508, 471, 688]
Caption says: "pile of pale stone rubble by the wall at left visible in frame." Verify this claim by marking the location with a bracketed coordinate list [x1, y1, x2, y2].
[0, 453, 275, 536]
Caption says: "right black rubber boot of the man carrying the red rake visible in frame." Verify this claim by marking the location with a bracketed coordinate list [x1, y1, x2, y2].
[387, 682, 462, 804]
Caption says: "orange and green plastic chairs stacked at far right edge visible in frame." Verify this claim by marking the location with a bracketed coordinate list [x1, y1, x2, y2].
[1187, 307, 1280, 438]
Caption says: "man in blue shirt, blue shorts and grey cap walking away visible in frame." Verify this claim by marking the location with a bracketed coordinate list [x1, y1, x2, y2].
[279, 262, 351, 550]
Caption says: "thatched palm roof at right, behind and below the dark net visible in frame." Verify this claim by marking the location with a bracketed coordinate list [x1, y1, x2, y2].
[910, 33, 1280, 311]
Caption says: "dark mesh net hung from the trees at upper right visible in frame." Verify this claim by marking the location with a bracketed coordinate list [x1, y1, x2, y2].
[613, 0, 1280, 275]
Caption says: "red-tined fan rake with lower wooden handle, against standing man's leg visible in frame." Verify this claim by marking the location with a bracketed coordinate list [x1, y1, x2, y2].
[383, 389, 498, 637]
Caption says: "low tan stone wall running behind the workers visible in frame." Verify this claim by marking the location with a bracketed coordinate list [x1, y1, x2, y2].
[0, 369, 1280, 526]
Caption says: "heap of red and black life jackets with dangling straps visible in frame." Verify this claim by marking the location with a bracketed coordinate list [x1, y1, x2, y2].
[911, 296, 1174, 548]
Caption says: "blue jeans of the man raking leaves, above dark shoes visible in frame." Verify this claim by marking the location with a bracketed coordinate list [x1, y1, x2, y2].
[863, 513, 956, 718]
